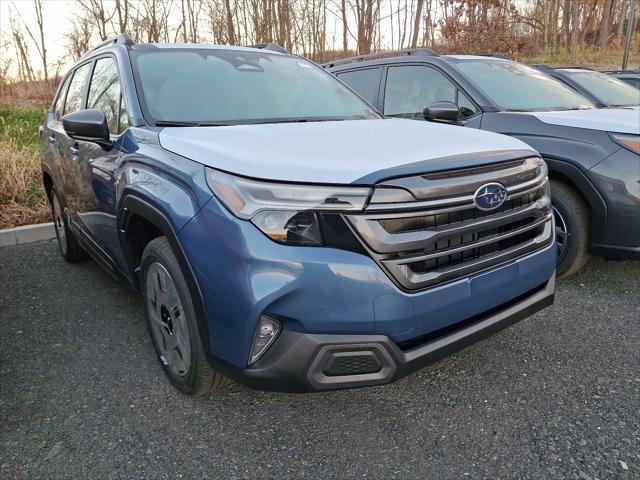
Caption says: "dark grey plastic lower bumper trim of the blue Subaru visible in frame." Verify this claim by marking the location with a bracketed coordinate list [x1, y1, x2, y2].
[213, 274, 555, 392]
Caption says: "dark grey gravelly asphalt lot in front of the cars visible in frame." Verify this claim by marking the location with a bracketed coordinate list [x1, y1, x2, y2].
[0, 242, 640, 480]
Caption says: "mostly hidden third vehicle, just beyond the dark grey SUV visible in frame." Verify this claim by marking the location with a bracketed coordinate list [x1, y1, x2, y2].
[533, 65, 640, 108]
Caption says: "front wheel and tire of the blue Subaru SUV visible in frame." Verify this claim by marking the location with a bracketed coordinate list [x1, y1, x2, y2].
[141, 237, 230, 395]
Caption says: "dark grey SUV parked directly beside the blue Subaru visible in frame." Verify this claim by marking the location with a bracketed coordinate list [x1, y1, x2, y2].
[325, 49, 640, 275]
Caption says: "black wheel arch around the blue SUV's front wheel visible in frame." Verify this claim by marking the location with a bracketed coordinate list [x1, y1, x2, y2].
[118, 194, 210, 352]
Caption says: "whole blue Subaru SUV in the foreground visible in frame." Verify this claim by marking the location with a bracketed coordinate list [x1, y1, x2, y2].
[41, 36, 556, 394]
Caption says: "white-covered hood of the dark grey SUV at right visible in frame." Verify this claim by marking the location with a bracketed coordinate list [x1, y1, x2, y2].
[531, 108, 640, 134]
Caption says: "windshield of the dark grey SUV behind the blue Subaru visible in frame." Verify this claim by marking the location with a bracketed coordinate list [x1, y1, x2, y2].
[457, 60, 593, 111]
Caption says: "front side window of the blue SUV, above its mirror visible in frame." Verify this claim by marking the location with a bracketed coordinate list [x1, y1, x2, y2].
[87, 57, 126, 134]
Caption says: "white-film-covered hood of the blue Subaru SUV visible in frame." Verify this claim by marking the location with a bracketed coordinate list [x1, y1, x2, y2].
[159, 119, 537, 184]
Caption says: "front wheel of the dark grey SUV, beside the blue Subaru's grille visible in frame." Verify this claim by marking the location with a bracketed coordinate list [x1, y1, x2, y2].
[551, 180, 590, 278]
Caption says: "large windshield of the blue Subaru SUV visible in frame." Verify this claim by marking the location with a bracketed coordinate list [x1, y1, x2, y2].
[132, 48, 378, 125]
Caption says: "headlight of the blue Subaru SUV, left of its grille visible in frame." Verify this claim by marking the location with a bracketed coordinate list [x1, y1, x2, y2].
[207, 168, 370, 246]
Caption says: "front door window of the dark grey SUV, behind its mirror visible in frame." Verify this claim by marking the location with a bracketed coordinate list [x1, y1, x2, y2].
[384, 65, 476, 119]
